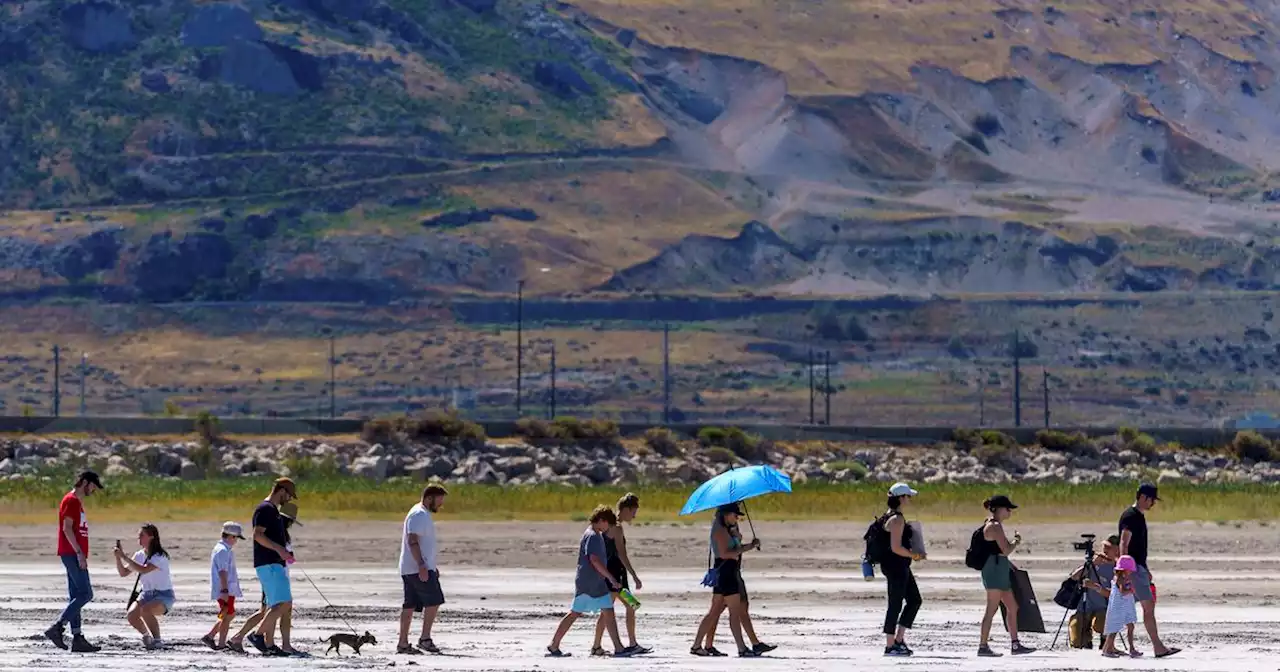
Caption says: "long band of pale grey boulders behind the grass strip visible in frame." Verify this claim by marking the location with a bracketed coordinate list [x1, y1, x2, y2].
[0, 438, 1280, 486]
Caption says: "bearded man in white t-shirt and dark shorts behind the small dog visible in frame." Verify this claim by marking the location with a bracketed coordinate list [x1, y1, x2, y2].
[396, 483, 449, 655]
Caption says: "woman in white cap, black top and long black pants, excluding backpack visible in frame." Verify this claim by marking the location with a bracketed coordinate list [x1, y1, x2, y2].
[879, 483, 924, 657]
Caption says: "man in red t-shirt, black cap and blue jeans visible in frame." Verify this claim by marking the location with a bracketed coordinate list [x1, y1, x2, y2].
[45, 471, 102, 653]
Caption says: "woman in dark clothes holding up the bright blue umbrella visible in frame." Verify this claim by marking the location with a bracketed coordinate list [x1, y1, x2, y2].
[689, 502, 762, 658]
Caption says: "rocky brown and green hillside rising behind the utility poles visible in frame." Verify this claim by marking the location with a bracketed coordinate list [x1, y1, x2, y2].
[0, 0, 1280, 302]
